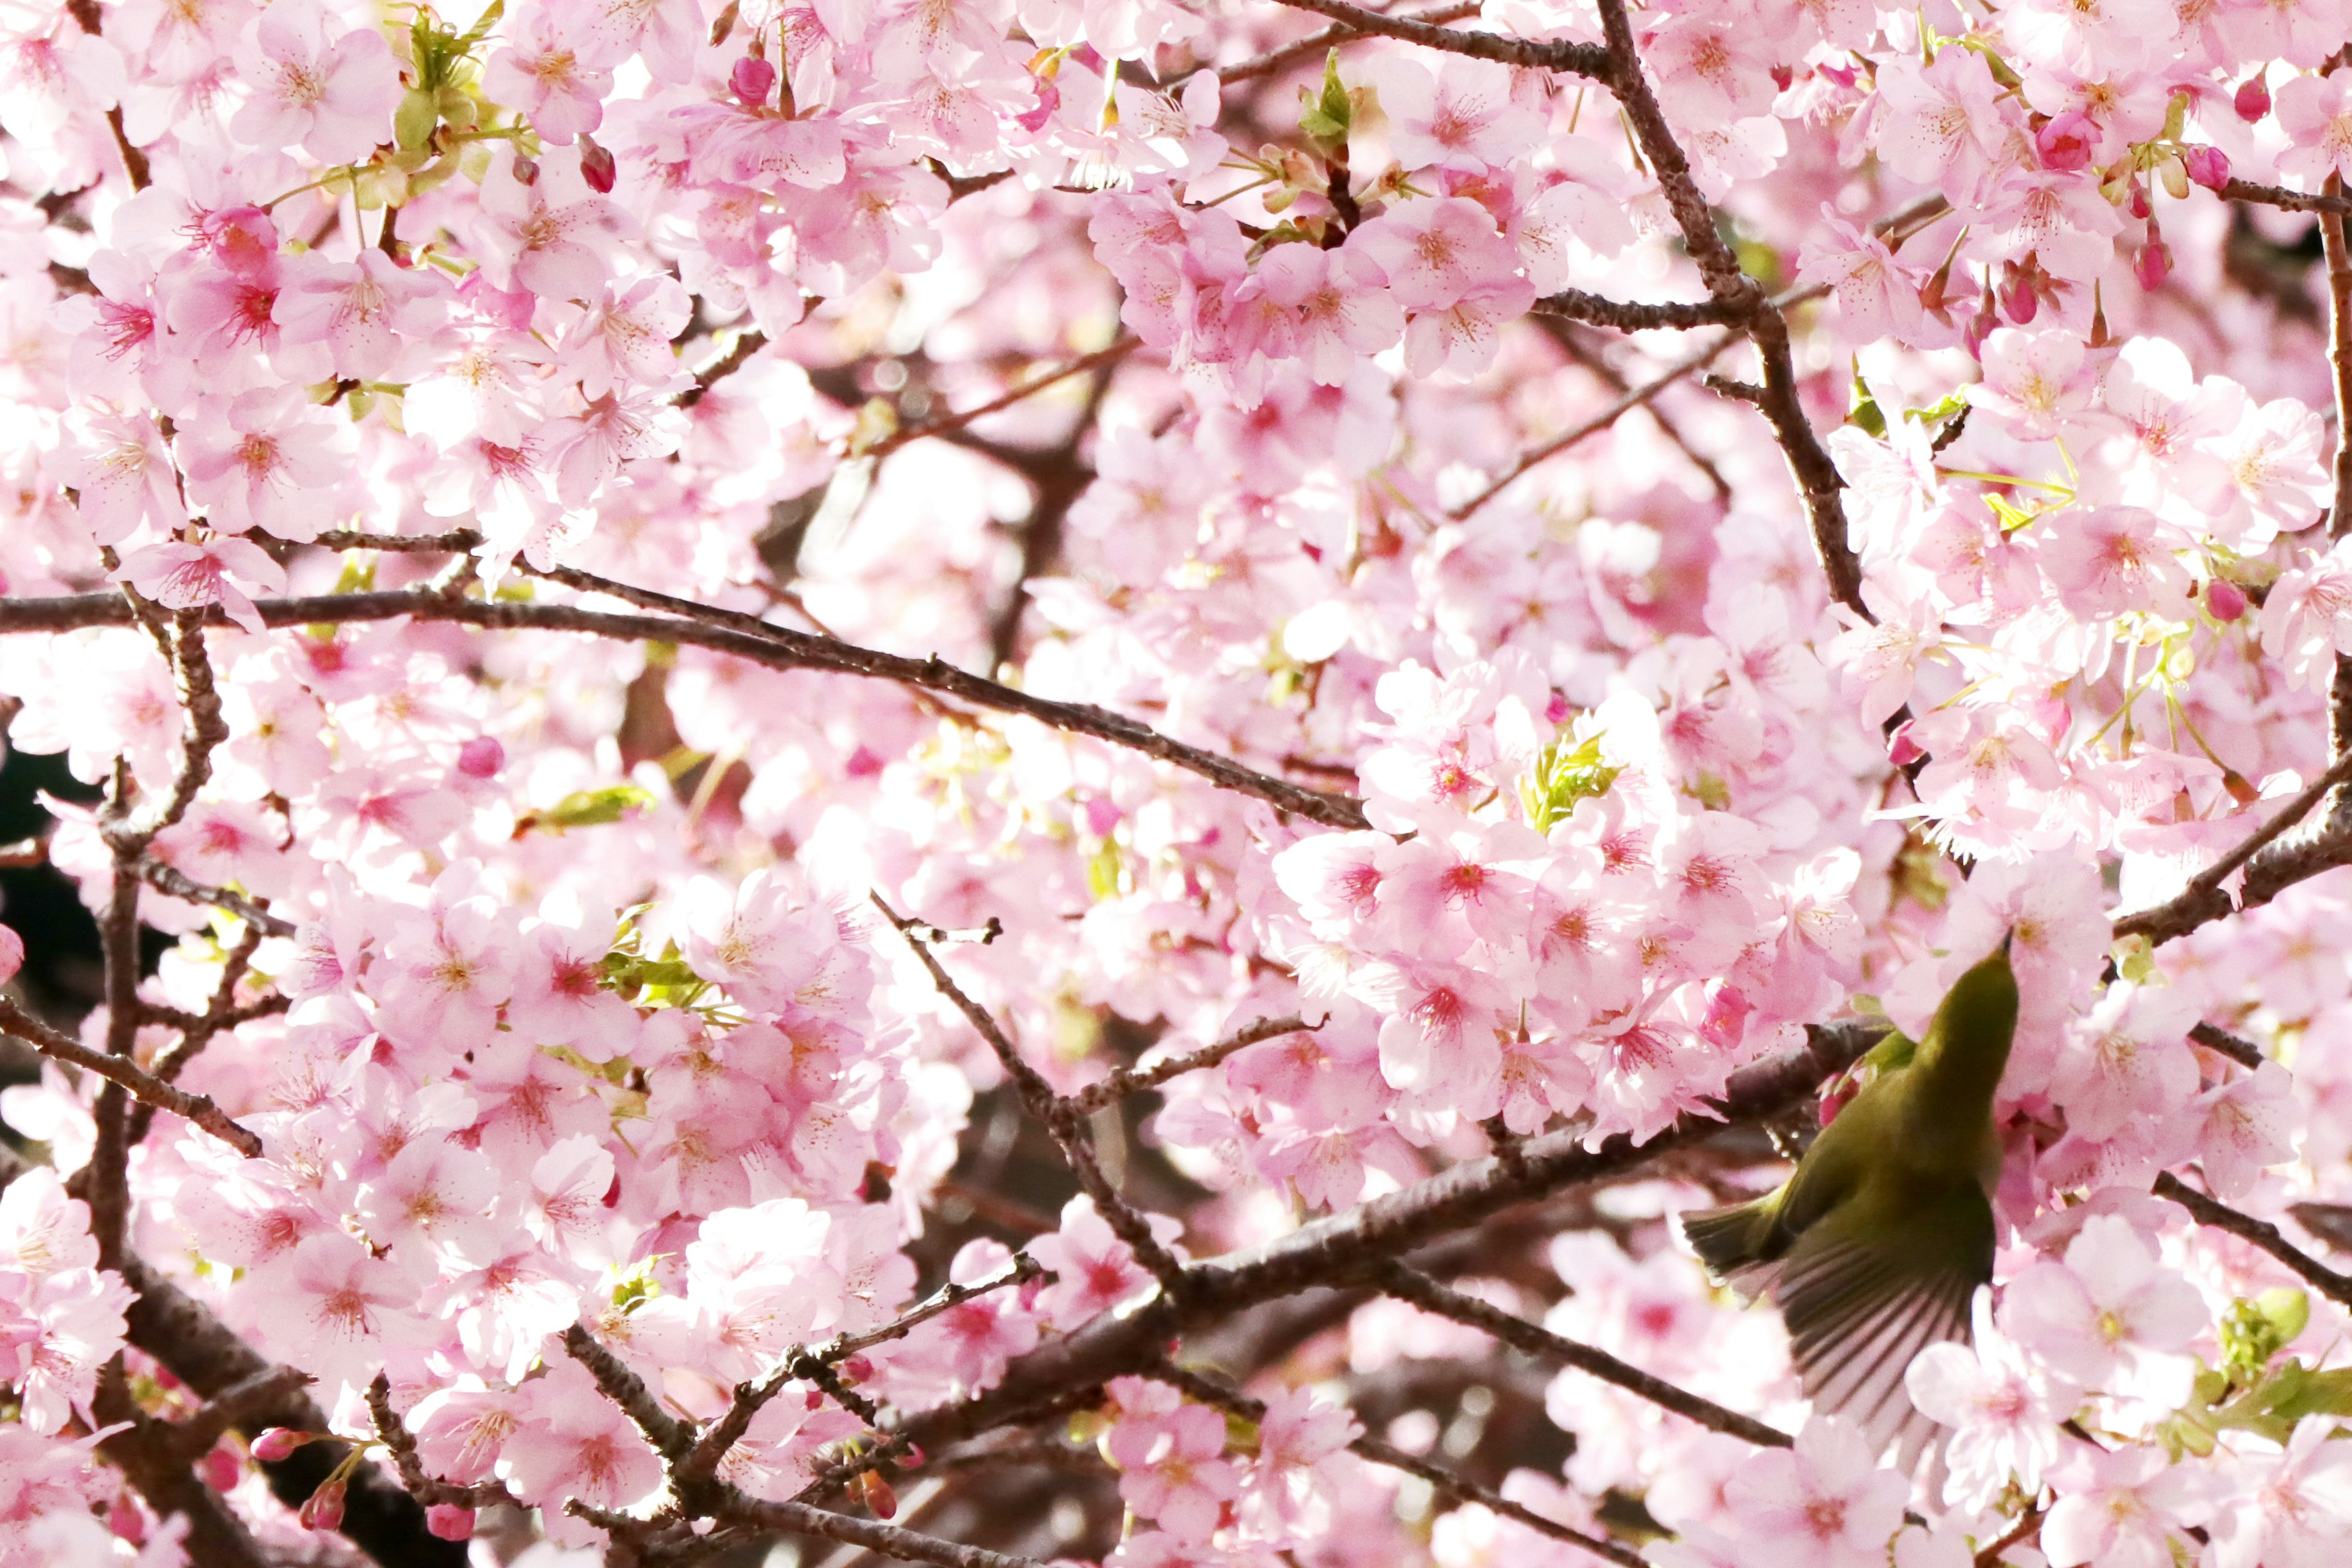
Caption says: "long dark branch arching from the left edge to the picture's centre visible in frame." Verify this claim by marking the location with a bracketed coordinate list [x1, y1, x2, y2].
[0, 590, 1371, 827]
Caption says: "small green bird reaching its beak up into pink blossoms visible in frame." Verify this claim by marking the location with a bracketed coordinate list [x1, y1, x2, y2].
[1682, 938, 2018, 1469]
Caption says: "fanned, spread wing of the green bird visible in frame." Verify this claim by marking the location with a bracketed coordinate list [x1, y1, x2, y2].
[1771, 1175, 1992, 1467]
